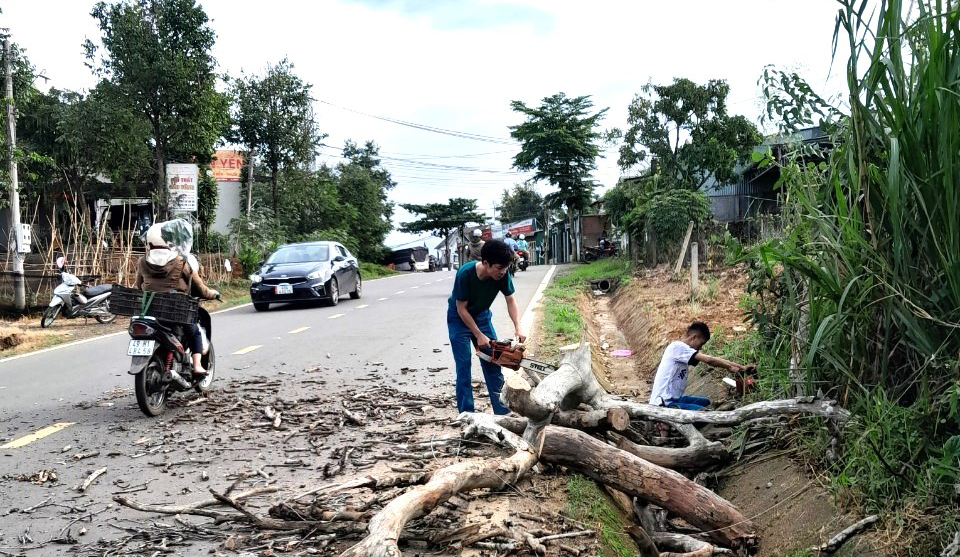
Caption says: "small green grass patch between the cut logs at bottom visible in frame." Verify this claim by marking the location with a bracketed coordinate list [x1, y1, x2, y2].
[567, 474, 639, 557]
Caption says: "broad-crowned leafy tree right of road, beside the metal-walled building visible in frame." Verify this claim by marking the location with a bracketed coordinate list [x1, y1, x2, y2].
[614, 78, 761, 190]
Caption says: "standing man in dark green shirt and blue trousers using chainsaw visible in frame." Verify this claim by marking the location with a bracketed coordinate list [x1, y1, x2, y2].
[447, 240, 524, 414]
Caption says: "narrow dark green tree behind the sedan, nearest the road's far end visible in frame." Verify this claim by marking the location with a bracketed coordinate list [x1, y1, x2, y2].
[337, 140, 396, 261]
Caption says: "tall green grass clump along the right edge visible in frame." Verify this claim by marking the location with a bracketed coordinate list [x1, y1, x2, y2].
[754, 0, 960, 548]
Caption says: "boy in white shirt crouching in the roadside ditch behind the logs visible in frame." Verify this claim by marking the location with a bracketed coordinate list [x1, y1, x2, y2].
[650, 321, 746, 410]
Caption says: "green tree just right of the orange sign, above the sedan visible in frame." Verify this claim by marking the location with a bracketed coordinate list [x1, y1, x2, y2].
[230, 58, 326, 216]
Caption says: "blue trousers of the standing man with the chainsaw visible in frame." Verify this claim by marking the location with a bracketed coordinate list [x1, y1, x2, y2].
[447, 308, 510, 414]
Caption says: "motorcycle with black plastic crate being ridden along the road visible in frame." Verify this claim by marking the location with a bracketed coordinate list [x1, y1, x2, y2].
[120, 287, 216, 417]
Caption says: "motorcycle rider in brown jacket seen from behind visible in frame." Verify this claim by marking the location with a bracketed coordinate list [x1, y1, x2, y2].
[136, 223, 220, 375]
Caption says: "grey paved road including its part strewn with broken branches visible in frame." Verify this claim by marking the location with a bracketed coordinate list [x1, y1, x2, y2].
[0, 266, 548, 555]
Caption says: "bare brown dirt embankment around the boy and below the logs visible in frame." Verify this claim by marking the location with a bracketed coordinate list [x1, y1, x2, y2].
[580, 267, 872, 556]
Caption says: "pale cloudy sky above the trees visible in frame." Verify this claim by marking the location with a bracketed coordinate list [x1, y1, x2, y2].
[0, 0, 843, 248]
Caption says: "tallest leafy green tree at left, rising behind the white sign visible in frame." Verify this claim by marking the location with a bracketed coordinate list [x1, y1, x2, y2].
[84, 0, 229, 211]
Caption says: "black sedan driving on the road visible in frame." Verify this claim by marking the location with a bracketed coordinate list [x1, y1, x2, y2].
[250, 242, 363, 311]
